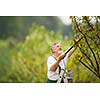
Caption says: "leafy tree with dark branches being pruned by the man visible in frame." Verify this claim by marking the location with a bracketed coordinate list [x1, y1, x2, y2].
[71, 16, 100, 82]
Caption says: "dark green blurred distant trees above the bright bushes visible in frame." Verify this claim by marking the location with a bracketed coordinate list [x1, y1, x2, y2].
[0, 16, 73, 41]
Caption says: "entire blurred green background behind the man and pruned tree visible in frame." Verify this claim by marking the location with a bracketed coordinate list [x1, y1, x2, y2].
[0, 16, 100, 83]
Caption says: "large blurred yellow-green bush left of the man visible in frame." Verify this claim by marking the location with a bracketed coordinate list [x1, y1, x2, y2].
[0, 24, 66, 83]
